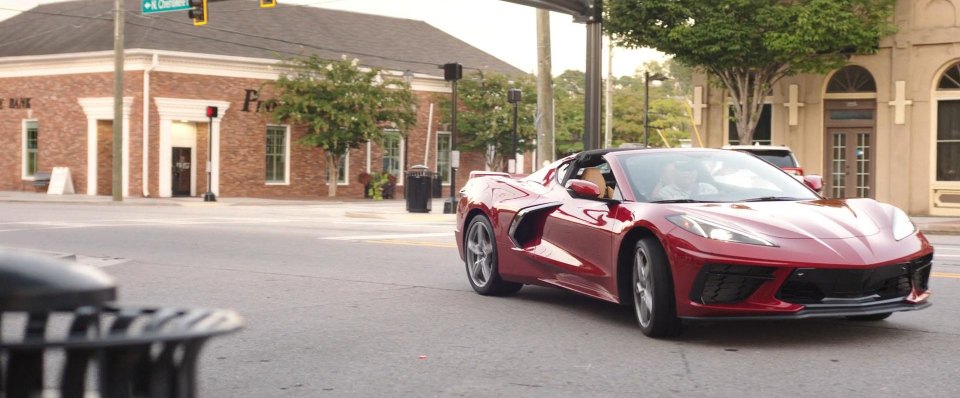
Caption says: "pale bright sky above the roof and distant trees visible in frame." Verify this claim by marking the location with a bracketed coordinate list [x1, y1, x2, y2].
[0, 0, 665, 77]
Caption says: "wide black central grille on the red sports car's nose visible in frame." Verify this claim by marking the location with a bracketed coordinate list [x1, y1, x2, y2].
[777, 256, 932, 304]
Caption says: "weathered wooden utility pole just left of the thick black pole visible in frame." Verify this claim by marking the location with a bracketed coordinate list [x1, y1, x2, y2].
[533, 9, 556, 170]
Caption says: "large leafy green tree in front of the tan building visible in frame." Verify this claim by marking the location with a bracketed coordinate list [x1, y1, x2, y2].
[605, 0, 896, 145]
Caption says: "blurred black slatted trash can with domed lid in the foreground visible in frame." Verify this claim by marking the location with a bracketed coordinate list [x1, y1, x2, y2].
[0, 250, 242, 398]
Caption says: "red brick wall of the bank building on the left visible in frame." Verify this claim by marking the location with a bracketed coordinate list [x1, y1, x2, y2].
[0, 72, 496, 198]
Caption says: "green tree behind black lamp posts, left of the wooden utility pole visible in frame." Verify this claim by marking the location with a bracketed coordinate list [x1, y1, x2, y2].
[440, 71, 537, 171]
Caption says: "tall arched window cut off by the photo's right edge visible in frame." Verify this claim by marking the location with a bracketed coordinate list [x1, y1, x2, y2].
[937, 62, 960, 181]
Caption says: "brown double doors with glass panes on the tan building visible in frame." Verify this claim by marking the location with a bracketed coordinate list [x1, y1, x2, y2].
[823, 100, 876, 198]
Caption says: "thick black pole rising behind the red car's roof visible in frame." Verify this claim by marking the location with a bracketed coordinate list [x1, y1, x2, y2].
[583, 20, 603, 150]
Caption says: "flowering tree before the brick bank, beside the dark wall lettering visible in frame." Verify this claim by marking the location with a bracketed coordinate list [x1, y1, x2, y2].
[270, 56, 416, 197]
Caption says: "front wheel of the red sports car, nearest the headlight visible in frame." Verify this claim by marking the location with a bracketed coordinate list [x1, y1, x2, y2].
[631, 238, 683, 337]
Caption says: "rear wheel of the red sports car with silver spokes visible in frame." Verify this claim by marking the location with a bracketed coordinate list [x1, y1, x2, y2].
[463, 215, 523, 296]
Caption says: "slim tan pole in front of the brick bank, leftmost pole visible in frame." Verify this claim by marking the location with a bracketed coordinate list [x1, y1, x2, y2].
[111, 0, 123, 202]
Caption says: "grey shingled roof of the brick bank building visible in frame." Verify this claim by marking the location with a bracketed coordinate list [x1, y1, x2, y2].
[0, 0, 524, 76]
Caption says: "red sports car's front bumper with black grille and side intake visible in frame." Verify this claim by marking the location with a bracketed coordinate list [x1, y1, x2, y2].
[671, 239, 933, 319]
